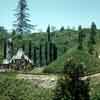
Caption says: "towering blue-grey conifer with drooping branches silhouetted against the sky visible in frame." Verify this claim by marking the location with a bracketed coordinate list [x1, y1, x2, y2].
[14, 0, 33, 35]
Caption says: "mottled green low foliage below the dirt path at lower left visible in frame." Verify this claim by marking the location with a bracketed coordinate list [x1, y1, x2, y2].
[0, 77, 52, 100]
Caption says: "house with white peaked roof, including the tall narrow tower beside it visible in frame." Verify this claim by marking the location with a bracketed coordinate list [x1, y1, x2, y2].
[0, 39, 33, 70]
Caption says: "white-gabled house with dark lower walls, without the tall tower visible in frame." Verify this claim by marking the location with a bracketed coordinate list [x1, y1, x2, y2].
[1, 48, 33, 70]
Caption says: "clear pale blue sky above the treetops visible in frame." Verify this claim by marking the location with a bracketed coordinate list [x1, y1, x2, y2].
[0, 0, 100, 31]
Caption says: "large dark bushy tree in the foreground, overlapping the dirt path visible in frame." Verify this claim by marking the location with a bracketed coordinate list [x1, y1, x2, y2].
[53, 58, 90, 100]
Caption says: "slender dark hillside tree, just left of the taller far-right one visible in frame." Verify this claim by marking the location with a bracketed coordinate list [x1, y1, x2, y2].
[78, 25, 84, 50]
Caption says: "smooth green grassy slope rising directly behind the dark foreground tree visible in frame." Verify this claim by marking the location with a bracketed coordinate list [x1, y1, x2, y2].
[44, 48, 100, 74]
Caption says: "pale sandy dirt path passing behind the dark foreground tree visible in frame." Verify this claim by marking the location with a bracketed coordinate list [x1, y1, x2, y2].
[16, 73, 100, 88]
